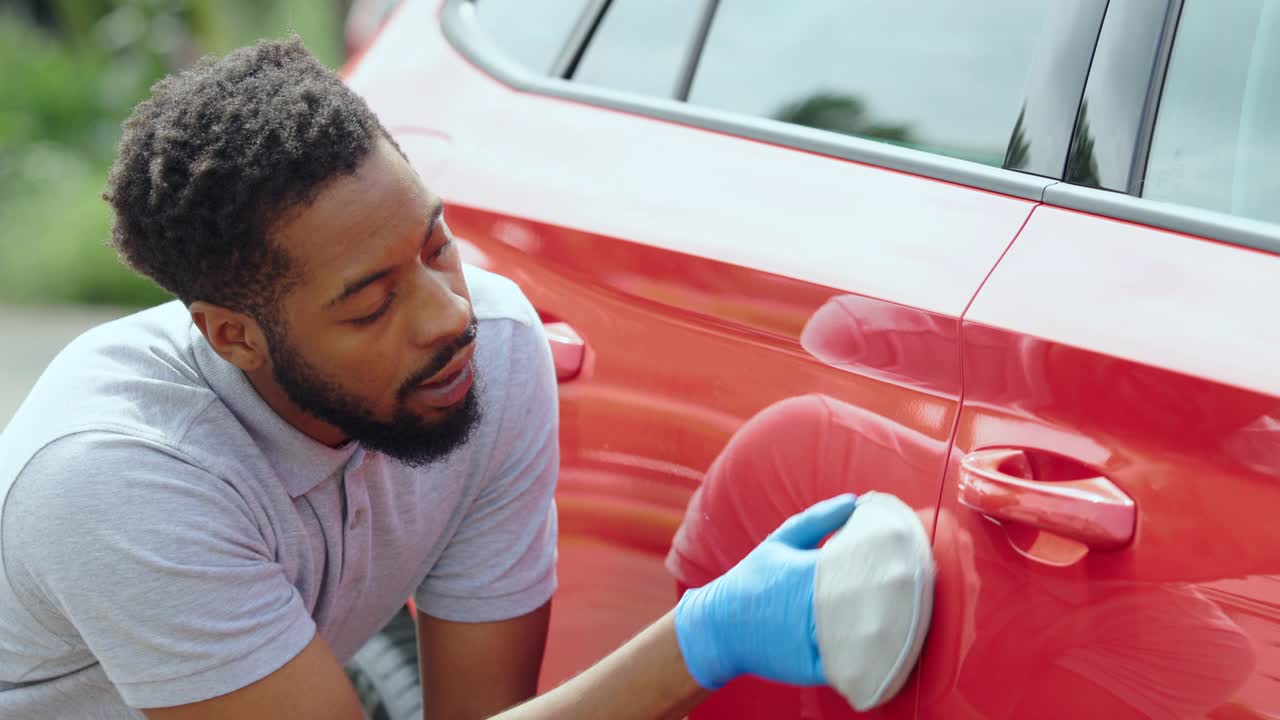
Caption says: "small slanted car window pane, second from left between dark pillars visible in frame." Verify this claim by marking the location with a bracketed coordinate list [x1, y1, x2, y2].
[573, 0, 705, 97]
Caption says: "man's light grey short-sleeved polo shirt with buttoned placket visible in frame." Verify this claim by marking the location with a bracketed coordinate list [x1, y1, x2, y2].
[0, 268, 559, 719]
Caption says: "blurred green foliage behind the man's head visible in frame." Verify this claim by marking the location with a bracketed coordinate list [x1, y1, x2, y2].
[0, 0, 344, 306]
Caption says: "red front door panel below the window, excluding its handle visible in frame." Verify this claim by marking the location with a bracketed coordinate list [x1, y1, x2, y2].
[922, 206, 1280, 719]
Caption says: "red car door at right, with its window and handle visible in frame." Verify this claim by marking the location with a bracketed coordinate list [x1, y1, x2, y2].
[920, 0, 1280, 720]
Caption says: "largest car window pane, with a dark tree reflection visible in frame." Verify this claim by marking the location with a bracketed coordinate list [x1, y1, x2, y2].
[689, 0, 1056, 165]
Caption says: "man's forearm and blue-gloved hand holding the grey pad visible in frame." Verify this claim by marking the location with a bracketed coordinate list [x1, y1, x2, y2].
[494, 495, 870, 720]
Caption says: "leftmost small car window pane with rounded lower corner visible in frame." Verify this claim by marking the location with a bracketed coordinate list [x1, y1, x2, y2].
[475, 0, 588, 74]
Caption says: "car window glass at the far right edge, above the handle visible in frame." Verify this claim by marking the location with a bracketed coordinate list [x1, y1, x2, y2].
[1143, 0, 1280, 223]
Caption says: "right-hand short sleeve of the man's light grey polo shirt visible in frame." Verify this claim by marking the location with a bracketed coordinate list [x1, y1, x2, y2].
[415, 316, 559, 623]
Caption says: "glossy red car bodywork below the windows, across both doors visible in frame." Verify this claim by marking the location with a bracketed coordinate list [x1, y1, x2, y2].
[349, 3, 1280, 720]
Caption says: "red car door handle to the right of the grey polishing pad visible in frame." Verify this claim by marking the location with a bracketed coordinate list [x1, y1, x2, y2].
[960, 448, 1138, 550]
